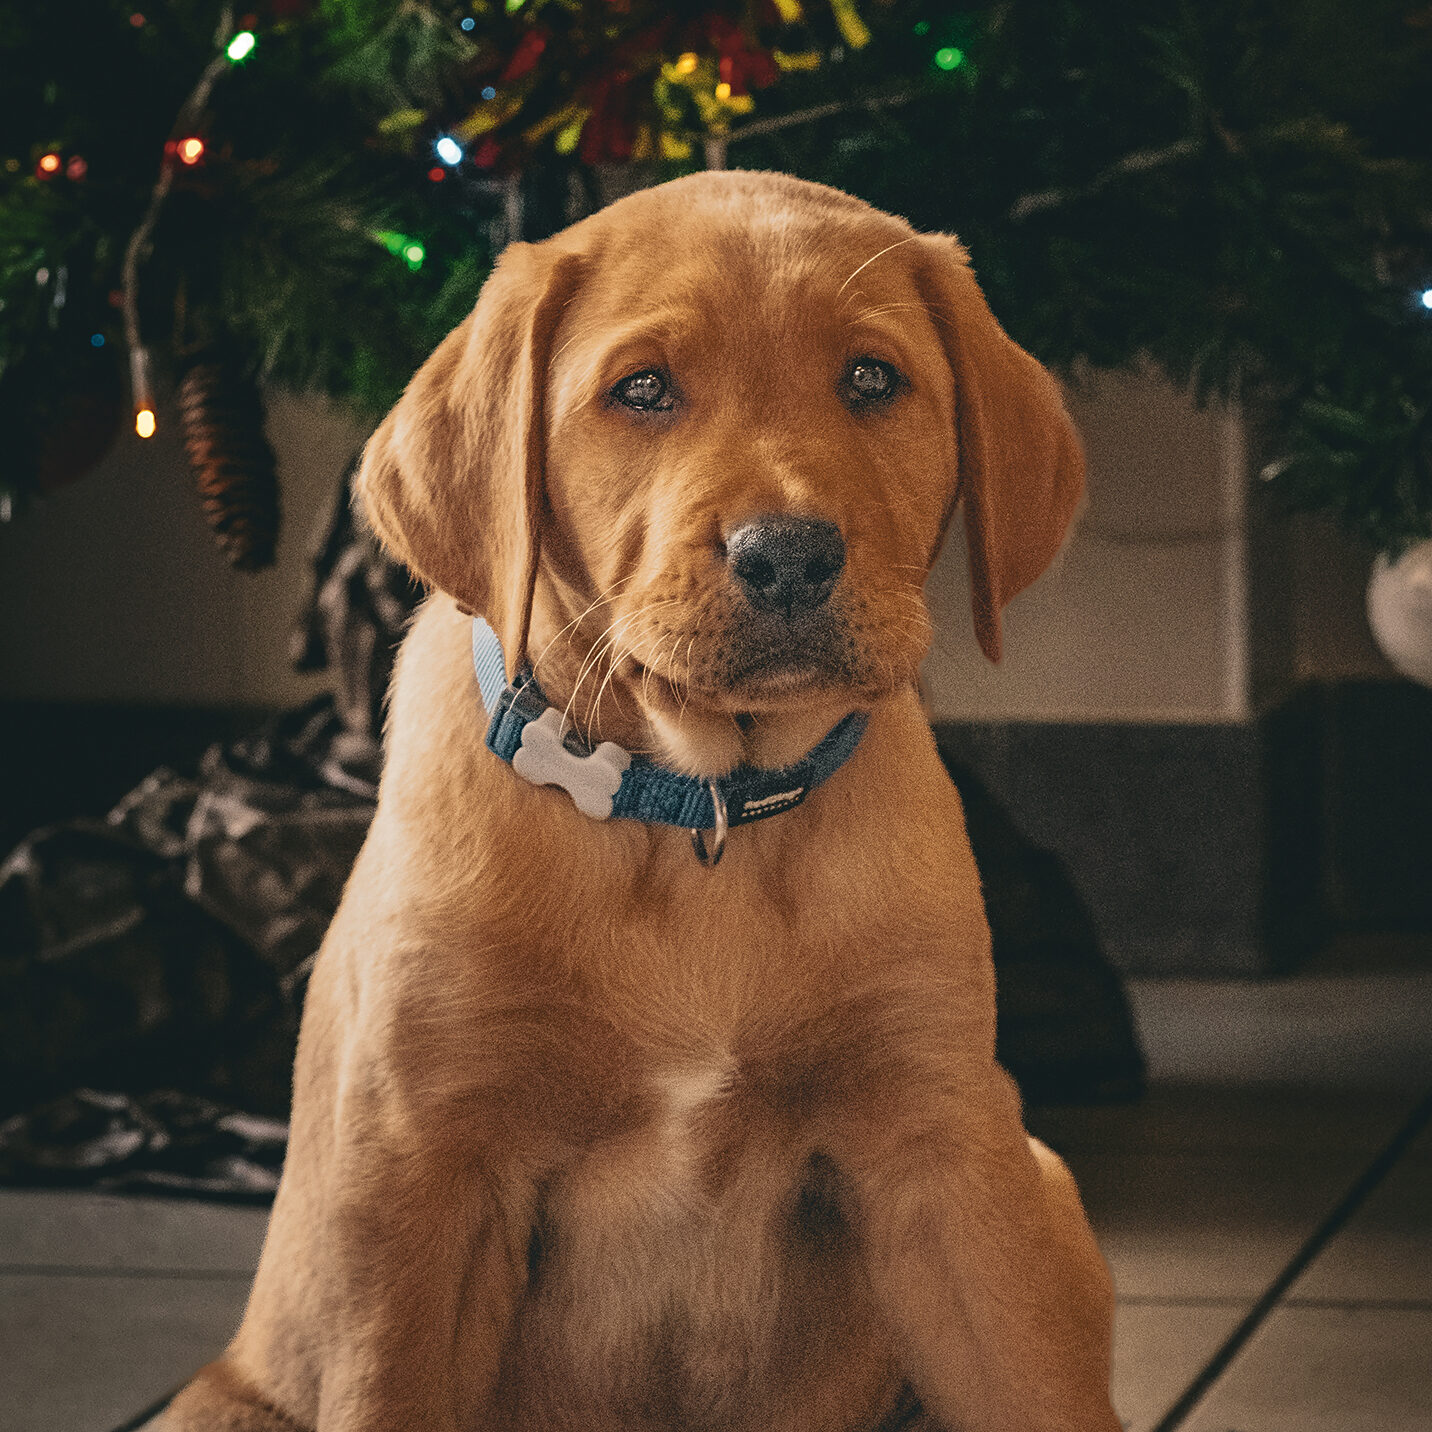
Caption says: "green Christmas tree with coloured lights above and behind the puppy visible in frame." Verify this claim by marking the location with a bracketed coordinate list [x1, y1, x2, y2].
[0, 0, 1432, 566]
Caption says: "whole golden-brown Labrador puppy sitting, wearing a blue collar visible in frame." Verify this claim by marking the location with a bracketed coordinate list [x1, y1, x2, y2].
[162, 173, 1118, 1432]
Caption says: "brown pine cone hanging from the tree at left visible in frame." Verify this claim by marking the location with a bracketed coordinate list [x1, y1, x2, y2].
[179, 349, 279, 571]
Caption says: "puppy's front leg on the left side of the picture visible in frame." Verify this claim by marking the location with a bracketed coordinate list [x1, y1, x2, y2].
[310, 1128, 531, 1432]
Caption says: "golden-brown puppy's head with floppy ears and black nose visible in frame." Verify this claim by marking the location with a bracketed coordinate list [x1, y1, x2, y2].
[359, 172, 1083, 775]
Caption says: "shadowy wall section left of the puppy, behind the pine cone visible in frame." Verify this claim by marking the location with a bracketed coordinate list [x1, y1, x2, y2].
[0, 394, 364, 706]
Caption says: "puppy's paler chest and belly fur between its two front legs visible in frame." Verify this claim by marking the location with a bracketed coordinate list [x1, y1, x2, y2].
[504, 1060, 849, 1426]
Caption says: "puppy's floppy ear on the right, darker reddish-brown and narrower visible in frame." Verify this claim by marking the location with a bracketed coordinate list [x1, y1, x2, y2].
[916, 233, 1084, 662]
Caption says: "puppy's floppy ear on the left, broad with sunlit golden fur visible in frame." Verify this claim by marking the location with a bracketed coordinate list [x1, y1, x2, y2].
[358, 243, 580, 677]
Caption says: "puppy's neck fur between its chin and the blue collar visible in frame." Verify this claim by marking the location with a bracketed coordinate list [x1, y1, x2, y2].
[527, 600, 855, 776]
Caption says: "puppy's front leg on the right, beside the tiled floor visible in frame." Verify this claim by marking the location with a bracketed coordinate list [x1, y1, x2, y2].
[838, 1070, 1120, 1432]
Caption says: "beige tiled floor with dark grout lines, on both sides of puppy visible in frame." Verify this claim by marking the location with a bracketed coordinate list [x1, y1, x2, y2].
[0, 961, 1432, 1432]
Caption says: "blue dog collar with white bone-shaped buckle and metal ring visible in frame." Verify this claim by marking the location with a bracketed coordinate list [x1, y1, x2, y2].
[473, 617, 866, 865]
